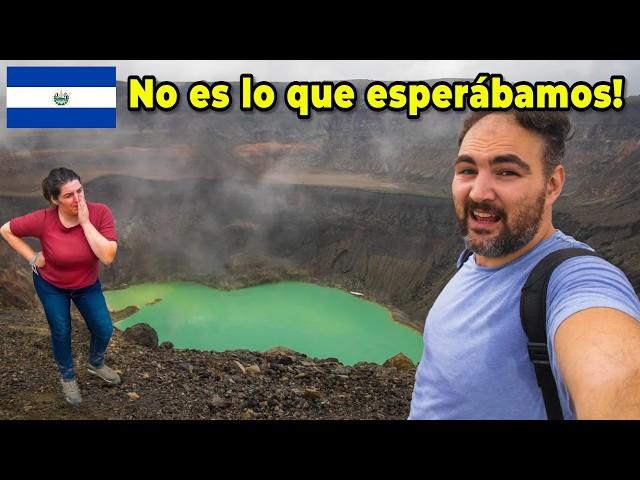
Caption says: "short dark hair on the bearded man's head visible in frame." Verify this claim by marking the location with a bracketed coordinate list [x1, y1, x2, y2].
[458, 110, 573, 178]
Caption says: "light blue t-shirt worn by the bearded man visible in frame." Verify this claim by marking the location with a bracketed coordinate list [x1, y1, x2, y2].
[409, 231, 640, 420]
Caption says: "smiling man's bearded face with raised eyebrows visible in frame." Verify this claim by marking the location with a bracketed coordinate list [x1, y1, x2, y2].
[452, 114, 547, 258]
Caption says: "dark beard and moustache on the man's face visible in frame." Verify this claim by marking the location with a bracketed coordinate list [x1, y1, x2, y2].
[456, 190, 546, 258]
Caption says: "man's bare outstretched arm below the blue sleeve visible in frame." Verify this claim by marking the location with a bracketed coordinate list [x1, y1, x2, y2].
[554, 308, 640, 419]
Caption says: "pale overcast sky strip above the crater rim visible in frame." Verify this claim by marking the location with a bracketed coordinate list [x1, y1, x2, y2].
[5, 60, 640, 96]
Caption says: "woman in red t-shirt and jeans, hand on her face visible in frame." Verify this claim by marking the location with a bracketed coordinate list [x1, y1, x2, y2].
[0, 168, 120, 405]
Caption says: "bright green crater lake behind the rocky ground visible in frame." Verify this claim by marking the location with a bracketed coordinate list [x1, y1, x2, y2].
[104, 282, 422, 365]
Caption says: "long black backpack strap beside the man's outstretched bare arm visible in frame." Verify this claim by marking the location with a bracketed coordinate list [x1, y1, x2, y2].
[520, 248, 600, 420]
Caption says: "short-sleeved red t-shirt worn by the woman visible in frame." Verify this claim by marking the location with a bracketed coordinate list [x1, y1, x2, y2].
[9, 202, 118, 290]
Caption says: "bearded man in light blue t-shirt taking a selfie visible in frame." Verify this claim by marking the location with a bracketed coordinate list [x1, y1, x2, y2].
[409, 111, 640, 419]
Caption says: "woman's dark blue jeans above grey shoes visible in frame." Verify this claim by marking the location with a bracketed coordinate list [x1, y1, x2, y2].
[33, 273, 113, 380]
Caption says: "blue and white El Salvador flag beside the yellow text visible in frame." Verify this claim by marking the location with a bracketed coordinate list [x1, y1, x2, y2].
[7, 67, 116, 128]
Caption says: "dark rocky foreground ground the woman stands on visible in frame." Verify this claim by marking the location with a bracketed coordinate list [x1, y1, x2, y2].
[0, 309, 415, 420]
